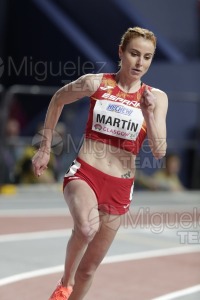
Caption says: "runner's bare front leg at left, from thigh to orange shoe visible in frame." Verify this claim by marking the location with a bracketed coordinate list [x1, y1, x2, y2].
[62, 179, 99, 286]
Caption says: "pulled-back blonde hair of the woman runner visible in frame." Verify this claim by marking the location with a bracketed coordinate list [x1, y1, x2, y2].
[119, 27, 156, 51]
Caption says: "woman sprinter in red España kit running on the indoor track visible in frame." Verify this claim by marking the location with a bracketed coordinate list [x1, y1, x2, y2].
[32, 27, 168, 300]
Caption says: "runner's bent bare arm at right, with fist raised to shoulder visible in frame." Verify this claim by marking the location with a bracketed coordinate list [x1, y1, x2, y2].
[141, 89, 168, 159]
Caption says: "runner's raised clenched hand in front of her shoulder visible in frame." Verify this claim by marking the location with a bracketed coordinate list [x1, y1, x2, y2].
[140, 88, 156, 118]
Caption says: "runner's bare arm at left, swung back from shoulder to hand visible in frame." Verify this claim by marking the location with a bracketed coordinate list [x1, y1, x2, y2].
[32, 74, 102, 176]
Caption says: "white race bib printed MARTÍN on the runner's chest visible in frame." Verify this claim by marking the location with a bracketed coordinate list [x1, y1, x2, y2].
[92, 100, 144, 141]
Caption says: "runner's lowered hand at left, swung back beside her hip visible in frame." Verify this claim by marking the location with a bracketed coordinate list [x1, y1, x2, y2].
[32, 149, 50, 177]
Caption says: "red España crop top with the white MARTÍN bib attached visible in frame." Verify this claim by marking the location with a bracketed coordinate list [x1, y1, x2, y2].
[85, 74, 151, 155]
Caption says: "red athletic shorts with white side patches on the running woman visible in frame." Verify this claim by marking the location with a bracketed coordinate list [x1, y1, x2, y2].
[63, 158, 134, 215]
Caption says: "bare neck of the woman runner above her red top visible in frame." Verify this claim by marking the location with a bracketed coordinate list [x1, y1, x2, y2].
[115, 71, 141, 93]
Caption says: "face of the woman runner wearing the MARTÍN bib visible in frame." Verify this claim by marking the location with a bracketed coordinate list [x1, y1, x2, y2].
[119, 37, 155, 79]
